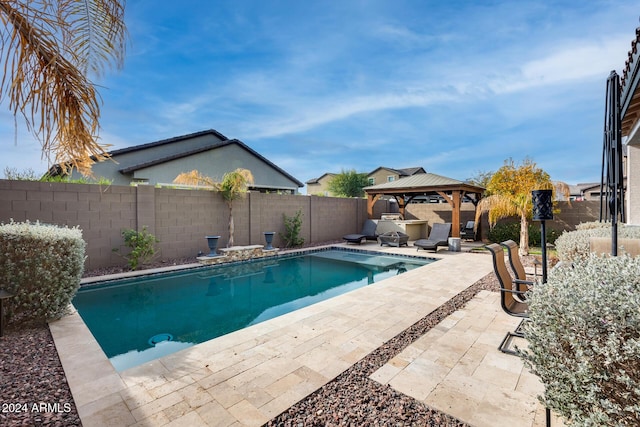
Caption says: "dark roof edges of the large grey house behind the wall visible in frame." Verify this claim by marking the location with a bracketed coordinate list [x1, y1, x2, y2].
[118, 137, 304, 187]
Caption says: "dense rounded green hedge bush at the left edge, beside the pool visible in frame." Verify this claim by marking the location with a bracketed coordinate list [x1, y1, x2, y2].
[0, 221, 86, 319]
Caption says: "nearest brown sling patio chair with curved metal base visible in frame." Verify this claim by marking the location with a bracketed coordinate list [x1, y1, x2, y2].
[486, 243, 529, 355]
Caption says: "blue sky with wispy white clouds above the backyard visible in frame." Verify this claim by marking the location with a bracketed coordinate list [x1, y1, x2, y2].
[0, 0, 640, 189]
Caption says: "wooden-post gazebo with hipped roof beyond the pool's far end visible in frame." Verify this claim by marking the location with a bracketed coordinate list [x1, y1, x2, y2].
[364, 173, 484, 237]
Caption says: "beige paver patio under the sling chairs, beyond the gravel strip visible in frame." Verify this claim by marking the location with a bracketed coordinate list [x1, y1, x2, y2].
[371, 291, 562, 427]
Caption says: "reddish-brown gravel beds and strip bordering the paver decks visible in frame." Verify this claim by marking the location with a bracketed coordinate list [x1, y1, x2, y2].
[0, 249, 512, 426]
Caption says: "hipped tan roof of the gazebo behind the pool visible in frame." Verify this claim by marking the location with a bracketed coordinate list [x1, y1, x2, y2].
[364, 173, 484, 194]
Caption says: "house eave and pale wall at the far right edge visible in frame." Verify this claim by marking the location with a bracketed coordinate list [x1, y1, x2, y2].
[620, 28, 640, 225]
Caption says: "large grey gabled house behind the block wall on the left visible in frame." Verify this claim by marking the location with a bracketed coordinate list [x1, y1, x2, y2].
[54, 129, 304, 194]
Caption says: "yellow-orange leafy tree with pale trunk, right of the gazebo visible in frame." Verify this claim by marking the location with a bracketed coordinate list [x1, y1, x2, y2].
[476, 159, 569, 255]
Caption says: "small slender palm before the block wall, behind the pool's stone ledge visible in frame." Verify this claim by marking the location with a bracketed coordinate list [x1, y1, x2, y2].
[173, 168, 254, 247]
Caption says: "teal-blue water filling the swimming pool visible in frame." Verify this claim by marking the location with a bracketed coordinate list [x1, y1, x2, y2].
[73, 249, 434, 371]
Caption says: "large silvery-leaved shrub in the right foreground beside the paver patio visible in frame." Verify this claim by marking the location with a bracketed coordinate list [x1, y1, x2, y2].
[522, 255, 640, 426]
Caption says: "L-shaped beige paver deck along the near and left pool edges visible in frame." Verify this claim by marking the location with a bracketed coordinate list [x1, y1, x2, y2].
[50, 245, 490, 425]
